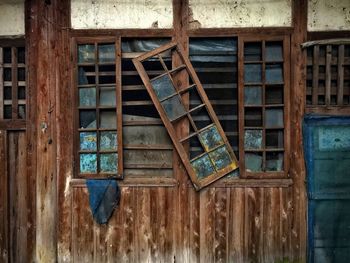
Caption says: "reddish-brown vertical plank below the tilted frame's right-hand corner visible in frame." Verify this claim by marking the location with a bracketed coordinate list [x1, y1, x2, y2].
[227, 188, 243, 263]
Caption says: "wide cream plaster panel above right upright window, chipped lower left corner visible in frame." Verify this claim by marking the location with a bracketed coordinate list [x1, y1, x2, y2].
[189, 0, 292, 28]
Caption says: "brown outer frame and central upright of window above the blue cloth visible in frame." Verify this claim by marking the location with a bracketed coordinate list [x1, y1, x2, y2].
[71, 37, 123, 179]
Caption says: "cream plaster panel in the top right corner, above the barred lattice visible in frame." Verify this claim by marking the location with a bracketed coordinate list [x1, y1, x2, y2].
[308, 0, 350, 31]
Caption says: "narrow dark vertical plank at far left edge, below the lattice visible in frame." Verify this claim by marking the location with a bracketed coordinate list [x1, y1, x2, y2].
[0, 130, 10, 263]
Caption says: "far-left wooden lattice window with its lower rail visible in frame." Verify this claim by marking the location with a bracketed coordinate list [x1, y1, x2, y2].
[0, 38, 27, 129]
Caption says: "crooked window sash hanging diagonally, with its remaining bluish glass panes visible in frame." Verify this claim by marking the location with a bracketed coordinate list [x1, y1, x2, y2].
[133, 42, 238, 190]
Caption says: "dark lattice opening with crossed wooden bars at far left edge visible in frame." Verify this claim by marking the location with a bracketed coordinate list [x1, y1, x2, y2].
[0, 43, 26, 120]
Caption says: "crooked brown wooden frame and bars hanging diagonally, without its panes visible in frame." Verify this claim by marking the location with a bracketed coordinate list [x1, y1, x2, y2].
[133, 42, 238, 190]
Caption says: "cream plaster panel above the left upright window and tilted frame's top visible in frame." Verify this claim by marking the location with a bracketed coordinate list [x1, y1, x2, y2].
[71, 0, 173, 29]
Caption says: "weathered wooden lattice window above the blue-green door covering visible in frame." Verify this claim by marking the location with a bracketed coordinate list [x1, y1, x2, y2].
[302, 38, 350, 115]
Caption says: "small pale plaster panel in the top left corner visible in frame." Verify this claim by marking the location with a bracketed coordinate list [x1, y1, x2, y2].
[0, 0, 24, 36]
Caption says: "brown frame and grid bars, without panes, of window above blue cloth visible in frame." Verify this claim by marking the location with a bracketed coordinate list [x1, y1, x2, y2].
[72, 37, 123, 179]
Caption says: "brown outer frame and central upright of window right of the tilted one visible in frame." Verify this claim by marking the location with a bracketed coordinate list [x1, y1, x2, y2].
[238, 35, 291, 179]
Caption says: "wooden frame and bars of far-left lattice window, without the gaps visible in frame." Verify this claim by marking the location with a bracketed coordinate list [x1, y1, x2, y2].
[0, 38, 28, 130]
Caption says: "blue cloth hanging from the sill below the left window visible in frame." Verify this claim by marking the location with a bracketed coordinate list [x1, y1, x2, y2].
[86, 179, 120, 224]
